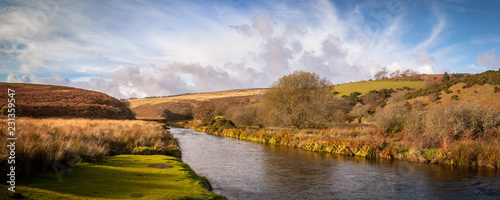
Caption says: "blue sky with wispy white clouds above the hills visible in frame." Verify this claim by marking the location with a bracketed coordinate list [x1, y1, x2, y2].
[0, 0, 500, 98]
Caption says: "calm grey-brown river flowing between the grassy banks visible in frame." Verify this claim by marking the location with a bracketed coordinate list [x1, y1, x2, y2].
[170, 128, 500, 199]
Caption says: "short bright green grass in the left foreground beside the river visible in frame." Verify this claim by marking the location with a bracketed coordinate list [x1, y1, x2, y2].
[1, 155, 225, 200]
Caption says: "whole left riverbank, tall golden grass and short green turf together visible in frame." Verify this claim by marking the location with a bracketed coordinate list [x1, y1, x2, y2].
[0, 118, 223, 199]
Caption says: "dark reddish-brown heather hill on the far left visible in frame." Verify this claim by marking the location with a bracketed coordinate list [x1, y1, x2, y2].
[0, 83, 135, 119]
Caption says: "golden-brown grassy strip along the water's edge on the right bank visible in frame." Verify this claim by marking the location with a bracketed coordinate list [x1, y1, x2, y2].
[183, 123, 500, 169]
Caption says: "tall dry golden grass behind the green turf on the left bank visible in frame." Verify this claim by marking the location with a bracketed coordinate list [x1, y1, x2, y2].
[0, 118, 180, 176]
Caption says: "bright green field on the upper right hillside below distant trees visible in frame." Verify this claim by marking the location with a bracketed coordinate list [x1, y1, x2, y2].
[335, 80, 425, 97]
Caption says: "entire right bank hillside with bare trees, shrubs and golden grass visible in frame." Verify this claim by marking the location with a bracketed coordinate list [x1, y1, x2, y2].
[163, 70, 500, 168]
